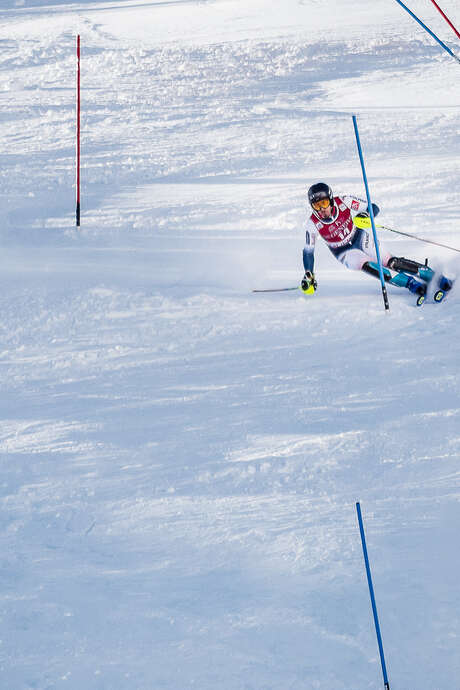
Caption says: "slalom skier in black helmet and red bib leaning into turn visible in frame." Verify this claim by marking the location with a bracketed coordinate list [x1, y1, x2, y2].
[301, 182, 452, 305]
